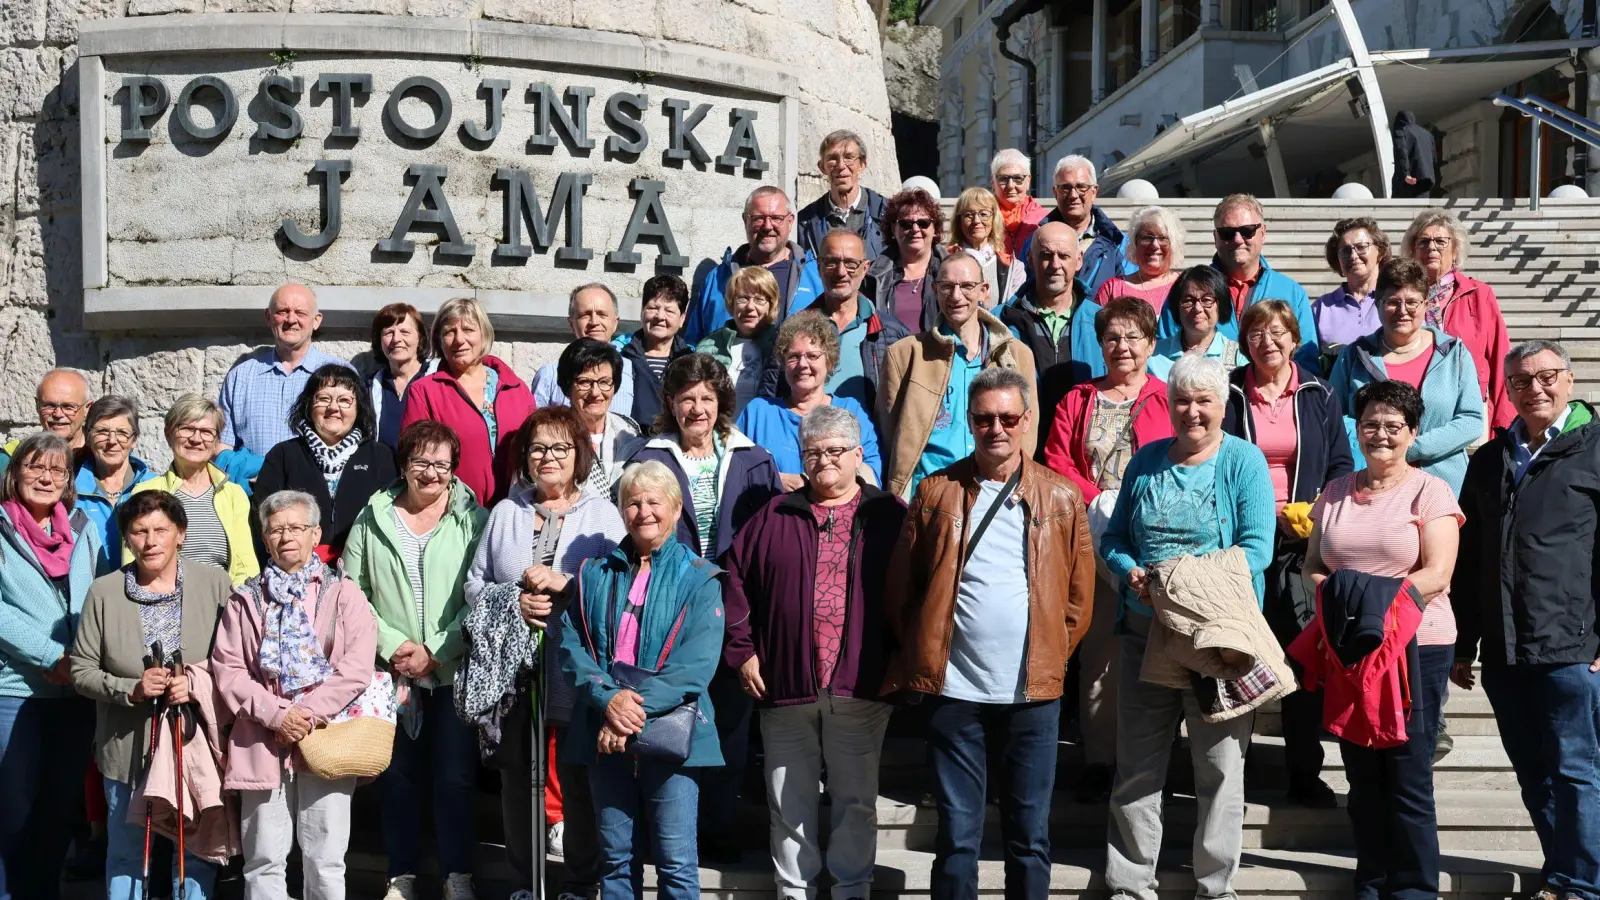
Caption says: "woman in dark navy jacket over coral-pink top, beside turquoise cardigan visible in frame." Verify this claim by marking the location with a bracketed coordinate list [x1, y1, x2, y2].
[1222, 299, 1354, 809]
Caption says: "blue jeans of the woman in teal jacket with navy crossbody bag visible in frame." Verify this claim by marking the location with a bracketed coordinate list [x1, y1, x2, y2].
[589, 753, 701, 900]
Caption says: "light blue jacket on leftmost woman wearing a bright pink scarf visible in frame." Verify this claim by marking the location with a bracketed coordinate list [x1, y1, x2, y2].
[0, 508, 101, 698]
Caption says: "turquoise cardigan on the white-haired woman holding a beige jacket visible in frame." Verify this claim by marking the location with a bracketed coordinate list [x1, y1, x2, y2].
[1099, 434, 1278, 621]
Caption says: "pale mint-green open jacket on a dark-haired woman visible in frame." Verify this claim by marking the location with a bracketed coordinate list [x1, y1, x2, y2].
[342, 479, 490, 684]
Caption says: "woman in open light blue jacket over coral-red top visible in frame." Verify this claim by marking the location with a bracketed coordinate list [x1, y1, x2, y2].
[1328, 259, 1485, 492]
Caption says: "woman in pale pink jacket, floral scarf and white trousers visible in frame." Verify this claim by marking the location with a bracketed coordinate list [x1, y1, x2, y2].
[211, 490, 378, 900]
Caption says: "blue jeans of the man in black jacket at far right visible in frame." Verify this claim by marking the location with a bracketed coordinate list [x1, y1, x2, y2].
[1483, 663, 1600, 900]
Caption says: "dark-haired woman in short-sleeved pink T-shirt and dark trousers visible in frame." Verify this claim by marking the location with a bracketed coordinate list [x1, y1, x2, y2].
[1306, 376, 1464, 897]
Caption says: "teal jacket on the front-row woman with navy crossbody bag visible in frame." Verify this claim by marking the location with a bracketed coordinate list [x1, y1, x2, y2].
[560, 538, 726, 765]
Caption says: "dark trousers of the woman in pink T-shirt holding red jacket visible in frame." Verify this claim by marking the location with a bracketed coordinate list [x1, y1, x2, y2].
[1339, 645, 1456, 900]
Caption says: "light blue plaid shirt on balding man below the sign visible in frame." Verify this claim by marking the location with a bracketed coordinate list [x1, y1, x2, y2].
[218, 346, 350, 456]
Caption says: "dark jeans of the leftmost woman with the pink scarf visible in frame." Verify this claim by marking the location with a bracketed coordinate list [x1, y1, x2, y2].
[0, 697, 94, 900]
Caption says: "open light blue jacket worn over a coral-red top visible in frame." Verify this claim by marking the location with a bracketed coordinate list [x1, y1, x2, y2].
[1328, 328, 1486, 496]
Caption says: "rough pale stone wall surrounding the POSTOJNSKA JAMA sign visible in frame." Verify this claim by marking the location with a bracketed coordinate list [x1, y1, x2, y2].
[0, 0, 899, 464]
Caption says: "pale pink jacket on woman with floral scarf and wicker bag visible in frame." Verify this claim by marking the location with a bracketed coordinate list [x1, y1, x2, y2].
[211, 569, 378, 791]
